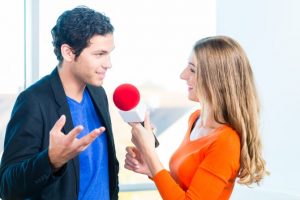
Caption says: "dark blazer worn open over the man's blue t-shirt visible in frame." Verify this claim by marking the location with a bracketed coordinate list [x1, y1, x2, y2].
[0, 69, 119, 200]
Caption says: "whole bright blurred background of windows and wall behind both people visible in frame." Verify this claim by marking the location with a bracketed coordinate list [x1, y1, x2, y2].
[0, 0, 300, 200]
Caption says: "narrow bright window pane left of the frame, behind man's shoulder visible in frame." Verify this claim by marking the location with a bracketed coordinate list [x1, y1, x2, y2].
[0, 0, 25, 155]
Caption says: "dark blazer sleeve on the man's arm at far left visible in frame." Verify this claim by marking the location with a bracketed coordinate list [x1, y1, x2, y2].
[0, 92, 64, 199]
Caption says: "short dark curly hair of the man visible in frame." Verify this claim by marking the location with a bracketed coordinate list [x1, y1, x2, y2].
[51, 6, 114, 65]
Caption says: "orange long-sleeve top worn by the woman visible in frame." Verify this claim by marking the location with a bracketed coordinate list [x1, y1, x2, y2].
[153, 110, 240, 200]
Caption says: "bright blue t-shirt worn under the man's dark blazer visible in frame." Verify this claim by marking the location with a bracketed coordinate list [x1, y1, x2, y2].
[67, 89, 109, 200]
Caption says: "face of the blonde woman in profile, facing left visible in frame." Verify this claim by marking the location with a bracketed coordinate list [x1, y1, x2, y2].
[180, 52, 199, 102]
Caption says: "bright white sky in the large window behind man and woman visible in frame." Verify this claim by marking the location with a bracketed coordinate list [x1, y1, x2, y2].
[39, 0, 216, 91]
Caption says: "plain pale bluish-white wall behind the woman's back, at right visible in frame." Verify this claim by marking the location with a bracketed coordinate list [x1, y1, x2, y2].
[217, 0, 300, 199]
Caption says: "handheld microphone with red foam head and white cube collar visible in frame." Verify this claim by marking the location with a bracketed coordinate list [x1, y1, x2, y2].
[113, 83, 159, 147]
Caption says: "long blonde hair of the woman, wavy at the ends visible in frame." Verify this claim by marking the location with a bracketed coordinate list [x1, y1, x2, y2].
[194, 36, 267, 185]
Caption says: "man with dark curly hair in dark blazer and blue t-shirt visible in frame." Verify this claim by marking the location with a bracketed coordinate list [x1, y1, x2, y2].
[0, 6, 119, 200]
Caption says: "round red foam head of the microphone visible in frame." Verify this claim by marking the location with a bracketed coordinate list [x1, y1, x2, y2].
[113, 83, 140, 111]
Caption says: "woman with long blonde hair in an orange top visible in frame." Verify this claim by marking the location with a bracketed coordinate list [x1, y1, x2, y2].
[125, 36, 267, 200]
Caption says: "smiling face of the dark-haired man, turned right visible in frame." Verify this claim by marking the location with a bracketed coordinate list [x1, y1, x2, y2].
[71, 34, 115, 86]
